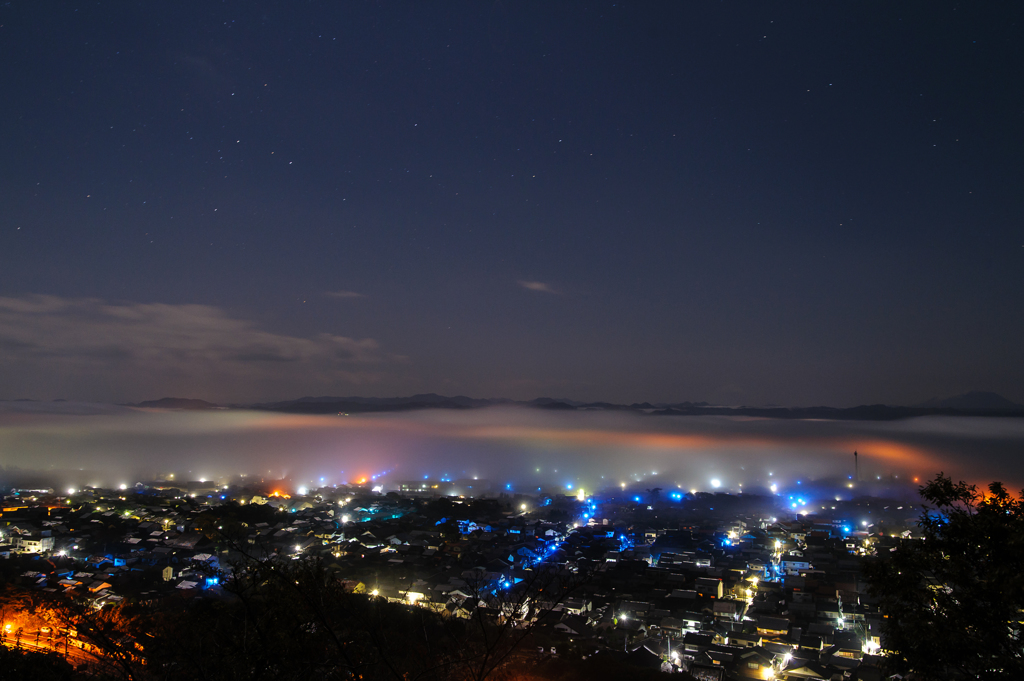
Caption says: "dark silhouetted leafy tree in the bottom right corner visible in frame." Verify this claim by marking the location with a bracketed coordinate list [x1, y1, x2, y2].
[867, 473, 1024, 679]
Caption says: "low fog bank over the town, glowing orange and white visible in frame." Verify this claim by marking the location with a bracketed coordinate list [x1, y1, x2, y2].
[0, 402, 1024, 493]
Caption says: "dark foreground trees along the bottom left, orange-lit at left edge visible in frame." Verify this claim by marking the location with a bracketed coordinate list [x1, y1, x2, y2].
[0, 544, 580, 681]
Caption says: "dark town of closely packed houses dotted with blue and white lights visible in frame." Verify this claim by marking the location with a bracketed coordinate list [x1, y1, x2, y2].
[0, 477, 912, 681]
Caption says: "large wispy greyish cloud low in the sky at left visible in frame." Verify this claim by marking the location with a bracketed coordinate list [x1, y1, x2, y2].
[0, 295, 395, 399]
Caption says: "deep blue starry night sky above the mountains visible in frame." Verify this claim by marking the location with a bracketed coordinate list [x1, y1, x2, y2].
[0, 0, 1024, 407]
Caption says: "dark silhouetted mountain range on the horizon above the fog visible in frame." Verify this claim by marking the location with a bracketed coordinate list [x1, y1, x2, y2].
[117, 392, 1024, 421]
